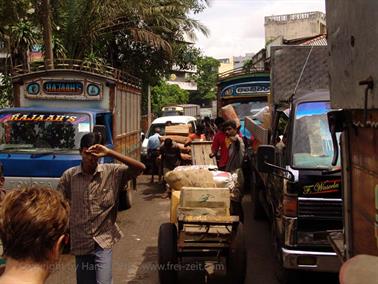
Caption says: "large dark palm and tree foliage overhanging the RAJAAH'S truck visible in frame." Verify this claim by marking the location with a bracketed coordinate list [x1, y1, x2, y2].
[0, 0, 208, 111]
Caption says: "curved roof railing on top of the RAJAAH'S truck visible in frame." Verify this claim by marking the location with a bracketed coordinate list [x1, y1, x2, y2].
[12, 59, 141, 88]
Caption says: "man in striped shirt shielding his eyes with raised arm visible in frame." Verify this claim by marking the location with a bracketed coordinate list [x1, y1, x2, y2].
[58, 133, 145, 284]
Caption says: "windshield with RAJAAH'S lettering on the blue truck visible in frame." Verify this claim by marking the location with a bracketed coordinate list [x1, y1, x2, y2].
[0, 112, 90, 152]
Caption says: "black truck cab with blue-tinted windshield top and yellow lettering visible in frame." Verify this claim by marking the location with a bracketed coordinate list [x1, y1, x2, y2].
[253, 90, 343, 278]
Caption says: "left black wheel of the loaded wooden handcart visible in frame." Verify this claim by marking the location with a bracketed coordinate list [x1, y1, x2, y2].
[158, 223, 178, 284]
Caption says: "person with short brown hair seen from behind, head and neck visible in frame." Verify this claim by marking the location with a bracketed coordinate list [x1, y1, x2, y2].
[0, 187, 69, 284]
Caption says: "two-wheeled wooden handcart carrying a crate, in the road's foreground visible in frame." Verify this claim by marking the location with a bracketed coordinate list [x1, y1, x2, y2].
[158, 187, 246, 284]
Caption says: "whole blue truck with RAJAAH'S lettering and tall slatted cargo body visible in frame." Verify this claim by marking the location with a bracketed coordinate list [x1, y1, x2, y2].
[0, 60, 141, 189]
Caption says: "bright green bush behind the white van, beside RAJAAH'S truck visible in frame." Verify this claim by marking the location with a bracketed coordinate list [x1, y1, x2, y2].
[151, 81, 189, 114]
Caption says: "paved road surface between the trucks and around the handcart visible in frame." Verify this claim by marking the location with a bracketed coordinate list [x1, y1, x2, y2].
[47, 176, 338, 284]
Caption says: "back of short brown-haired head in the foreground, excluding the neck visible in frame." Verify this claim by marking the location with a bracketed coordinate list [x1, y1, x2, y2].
[0, 187, 69, 264]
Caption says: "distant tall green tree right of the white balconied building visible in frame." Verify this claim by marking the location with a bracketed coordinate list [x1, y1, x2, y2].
[191, 56, 220, 104]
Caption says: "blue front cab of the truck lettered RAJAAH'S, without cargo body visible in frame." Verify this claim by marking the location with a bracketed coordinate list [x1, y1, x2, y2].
[0, 107, 113, 188]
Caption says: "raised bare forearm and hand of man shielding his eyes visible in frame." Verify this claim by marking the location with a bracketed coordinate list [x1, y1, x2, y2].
[87, 144, 146, 174]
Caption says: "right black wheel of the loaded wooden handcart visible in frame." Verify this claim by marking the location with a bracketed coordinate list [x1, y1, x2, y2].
[227, 223, 247, 284]
